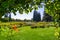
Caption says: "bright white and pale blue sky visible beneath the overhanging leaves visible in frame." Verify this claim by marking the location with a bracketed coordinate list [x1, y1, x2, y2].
[2, 3, 44, 20]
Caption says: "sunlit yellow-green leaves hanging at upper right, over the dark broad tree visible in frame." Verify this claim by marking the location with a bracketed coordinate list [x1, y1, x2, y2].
[45, 0, 60, 22]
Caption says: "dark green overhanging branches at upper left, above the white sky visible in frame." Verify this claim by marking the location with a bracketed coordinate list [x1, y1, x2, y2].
[0, 0, 40, 19]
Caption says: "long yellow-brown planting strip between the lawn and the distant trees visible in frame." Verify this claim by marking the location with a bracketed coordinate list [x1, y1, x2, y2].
[0, 22, 59, 28]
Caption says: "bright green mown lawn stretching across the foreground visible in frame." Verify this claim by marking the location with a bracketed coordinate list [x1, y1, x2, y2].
[0, 26, 58, 40]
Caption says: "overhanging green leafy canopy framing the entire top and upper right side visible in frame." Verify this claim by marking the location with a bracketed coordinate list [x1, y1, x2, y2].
[0, 0, 60, 21]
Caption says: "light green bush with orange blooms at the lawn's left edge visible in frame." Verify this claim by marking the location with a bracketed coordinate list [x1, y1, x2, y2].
[0, 26, 18, 40]
